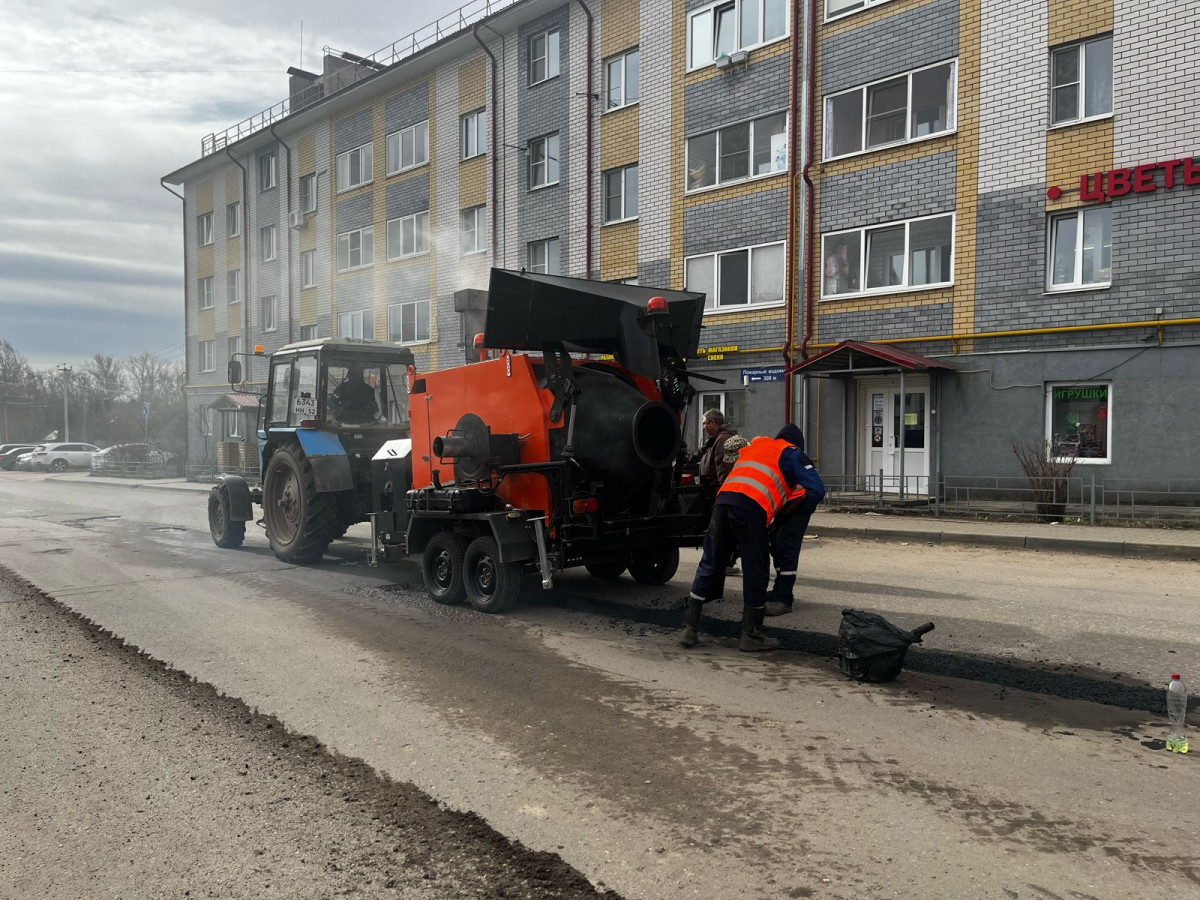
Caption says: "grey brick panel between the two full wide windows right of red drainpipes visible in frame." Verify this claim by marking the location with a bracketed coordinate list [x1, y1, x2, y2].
[820, 150, 956, 232]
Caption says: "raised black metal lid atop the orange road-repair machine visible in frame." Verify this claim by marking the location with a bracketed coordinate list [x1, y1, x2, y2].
[484, 269, 704, 379]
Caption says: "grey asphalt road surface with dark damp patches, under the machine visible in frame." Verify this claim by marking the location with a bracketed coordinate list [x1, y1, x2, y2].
[0, 473, 1200, 900]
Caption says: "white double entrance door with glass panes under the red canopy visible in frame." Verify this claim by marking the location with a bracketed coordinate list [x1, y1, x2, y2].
[865, 384, 930, 496]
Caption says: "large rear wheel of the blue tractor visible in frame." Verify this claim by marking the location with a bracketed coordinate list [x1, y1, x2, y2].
[263, 444, 338, 563]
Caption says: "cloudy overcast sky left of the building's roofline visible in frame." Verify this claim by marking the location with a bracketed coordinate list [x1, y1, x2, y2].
[0, 0, 464, 367]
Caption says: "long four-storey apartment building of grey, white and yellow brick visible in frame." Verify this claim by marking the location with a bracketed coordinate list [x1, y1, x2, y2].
[164, 0, 1200, 494]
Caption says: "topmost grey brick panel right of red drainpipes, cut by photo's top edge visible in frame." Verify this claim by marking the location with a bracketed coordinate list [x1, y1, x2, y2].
[815, 0, 959, 95]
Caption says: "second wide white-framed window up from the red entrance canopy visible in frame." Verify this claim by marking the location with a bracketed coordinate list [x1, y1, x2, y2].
[824, 60, 958, 160]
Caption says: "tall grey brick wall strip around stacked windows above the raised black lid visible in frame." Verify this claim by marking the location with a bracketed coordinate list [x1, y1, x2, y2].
[516, 5, 571, 274]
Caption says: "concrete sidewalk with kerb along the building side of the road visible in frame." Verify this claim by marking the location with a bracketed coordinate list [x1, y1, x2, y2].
[42, 473, 1200, 559]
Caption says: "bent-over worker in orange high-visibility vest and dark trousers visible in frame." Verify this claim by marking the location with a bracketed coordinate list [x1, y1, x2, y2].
[679, 424, 824, 652]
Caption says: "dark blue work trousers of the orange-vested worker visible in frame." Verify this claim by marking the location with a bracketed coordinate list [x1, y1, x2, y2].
[691, 503, 770, 607]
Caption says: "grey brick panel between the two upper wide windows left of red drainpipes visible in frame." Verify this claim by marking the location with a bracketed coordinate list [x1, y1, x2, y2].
[683, 54, 791, 134]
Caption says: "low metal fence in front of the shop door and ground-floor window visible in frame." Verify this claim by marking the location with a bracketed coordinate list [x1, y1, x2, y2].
[822, 473, 1200, 528]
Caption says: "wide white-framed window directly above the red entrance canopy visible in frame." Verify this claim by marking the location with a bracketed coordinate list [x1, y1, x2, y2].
[821, 214, 954, 298]
